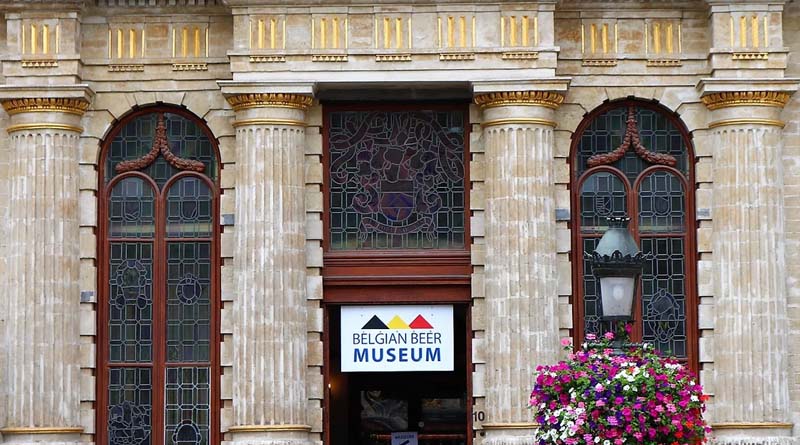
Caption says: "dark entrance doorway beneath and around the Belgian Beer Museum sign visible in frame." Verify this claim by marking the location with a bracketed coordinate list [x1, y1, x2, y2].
[326, 304, 472, 445]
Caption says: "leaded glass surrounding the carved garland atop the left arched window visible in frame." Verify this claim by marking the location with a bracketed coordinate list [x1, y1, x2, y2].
[105, 113, 217, 186]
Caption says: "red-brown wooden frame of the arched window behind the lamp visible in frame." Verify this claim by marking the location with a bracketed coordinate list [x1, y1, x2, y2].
[568, 98, 700, 373]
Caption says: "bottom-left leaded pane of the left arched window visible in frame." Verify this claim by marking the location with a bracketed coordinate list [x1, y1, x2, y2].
[107, 368, 153, 445]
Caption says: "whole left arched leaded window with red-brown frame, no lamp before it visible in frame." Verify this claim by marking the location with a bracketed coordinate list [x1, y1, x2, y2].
[97, 107, 219, 445]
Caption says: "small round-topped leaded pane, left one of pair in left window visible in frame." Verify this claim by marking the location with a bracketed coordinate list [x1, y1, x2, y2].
[108, 178, 155, 238]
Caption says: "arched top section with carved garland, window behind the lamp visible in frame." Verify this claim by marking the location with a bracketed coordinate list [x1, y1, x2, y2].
[573, 100, 690, 182]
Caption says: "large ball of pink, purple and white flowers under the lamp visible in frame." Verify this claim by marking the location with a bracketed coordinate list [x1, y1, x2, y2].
[530, 333, 710, 445]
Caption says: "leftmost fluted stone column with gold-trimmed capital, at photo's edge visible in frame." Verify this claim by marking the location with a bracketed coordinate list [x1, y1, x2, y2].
[0, 95, 88, 443]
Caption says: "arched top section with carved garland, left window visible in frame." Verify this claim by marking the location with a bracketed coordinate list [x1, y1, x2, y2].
[104, 107, 219, 187]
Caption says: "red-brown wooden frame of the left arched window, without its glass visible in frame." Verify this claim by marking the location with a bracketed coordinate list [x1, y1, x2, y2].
[94, 104, 223, 445]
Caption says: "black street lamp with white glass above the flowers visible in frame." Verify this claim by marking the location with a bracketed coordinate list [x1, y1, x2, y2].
[587, 217, 647, 322]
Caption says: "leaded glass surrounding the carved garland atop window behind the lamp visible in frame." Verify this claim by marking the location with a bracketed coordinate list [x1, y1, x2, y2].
[574, 106, 689, 182]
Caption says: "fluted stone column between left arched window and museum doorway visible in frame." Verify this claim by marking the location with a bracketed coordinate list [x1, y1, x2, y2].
[228, 94, 311, 444]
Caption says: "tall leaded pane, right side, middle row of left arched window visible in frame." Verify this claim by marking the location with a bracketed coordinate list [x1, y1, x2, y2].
[167, 243, 211, 362]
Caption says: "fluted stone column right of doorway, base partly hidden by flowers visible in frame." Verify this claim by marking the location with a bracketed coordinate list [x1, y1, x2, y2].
[475, 92, 563, 445]
